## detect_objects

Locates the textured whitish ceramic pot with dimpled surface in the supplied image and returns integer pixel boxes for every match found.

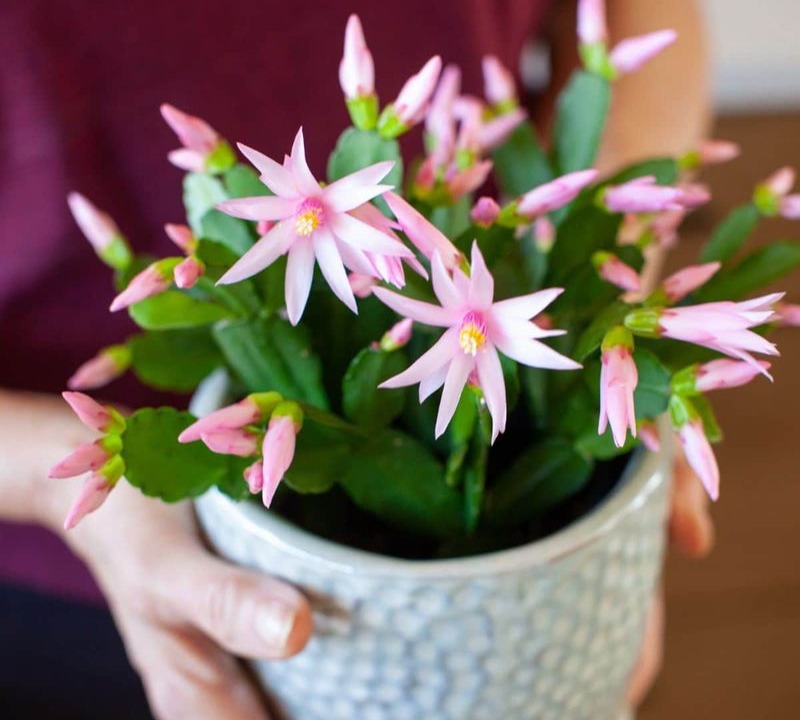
[193,372,671,720]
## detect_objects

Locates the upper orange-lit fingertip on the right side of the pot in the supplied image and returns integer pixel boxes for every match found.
[669,455,714,557]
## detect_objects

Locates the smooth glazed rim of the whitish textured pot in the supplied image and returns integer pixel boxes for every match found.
[191,376,672,581]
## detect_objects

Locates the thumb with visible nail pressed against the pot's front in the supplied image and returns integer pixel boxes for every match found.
[165,548,312,659]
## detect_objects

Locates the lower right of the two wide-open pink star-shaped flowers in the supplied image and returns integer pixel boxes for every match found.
[374,243,580,440]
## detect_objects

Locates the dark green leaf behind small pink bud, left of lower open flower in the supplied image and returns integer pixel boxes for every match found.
[342,348,408,430]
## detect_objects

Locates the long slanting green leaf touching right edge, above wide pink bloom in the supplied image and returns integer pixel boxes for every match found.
[696,240,800,302]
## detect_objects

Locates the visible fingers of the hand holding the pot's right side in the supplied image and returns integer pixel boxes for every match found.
[627,453,714,707]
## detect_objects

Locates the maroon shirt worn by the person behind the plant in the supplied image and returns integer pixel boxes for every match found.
[0,0,551,597]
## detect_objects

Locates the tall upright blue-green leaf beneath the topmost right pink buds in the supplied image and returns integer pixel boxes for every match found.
[553,70,611,175]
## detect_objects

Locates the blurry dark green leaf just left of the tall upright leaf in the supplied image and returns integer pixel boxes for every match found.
[492,122,553,197]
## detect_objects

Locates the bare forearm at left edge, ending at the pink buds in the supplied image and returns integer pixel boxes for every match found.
[0,389,92,529]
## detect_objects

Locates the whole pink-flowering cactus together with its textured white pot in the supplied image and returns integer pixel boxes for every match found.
[53,3,800,720]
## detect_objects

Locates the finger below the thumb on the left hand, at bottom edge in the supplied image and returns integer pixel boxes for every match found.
[125,621,269,720]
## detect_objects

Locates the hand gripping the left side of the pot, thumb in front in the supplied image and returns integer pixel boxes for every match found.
[26,396,312,720]
